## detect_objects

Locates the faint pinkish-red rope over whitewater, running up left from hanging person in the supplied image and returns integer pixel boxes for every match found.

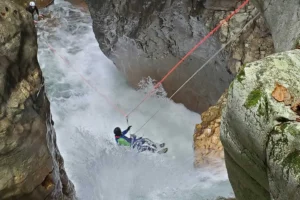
[47,44,127,118]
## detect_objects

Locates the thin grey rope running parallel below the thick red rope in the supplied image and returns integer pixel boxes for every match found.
[134,13,260,134]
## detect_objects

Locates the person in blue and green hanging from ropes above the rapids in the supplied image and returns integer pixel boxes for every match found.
[114,126,168,154]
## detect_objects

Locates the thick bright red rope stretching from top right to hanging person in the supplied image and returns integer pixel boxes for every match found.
[126,0,249,117]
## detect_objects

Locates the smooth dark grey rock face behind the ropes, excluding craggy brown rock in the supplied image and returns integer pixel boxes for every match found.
[86,0,232,112]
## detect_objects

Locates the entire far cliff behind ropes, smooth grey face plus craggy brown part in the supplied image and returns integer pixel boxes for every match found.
[86,0,273,112]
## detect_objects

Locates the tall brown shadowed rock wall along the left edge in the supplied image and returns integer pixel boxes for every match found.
[0,0,75,200]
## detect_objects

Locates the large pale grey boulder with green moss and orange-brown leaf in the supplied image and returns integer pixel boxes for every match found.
[221,50,300,200]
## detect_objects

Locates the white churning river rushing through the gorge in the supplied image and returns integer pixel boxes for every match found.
[37,0,232,200]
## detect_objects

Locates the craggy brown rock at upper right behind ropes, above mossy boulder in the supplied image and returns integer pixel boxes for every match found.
[199,0,274,74]
